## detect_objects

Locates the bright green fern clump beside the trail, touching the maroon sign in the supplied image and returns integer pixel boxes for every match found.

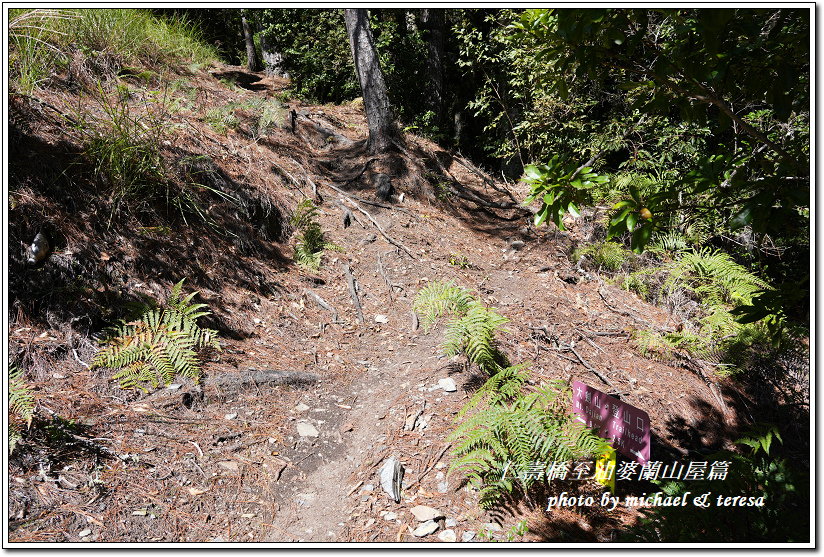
[413,282,606,507]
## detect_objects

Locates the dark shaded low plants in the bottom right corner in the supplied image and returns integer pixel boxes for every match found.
[622,426,811,543]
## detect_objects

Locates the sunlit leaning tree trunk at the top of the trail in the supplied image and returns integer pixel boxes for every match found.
[344,8,399,154]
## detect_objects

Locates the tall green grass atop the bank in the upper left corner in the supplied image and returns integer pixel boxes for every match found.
[9,8,218,93]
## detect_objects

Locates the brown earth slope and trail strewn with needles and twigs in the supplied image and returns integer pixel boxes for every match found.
[7,60,804,542]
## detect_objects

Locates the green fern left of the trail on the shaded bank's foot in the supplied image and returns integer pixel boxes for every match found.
[92,279,220,391]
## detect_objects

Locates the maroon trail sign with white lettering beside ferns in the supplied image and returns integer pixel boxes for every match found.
[572,381,649,464]
